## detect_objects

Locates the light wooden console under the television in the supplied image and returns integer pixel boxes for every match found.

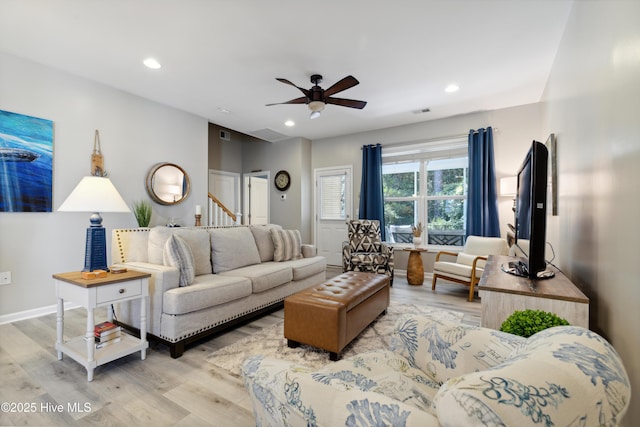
[478,255,589,330]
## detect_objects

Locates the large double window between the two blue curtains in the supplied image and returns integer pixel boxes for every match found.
[382,137,469,246]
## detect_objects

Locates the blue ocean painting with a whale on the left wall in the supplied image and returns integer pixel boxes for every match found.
[0,110,53,212]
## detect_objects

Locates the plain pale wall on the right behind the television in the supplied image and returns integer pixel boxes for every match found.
[545,0,640,426]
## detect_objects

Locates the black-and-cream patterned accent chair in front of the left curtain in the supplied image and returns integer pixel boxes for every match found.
[342,219,393,286]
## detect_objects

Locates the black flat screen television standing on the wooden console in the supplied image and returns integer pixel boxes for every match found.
[511,141,553,279]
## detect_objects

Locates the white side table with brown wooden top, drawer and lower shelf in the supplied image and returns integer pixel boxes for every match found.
[53,271,151,381]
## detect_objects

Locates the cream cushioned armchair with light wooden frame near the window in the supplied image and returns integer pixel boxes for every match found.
[431,236,509,301]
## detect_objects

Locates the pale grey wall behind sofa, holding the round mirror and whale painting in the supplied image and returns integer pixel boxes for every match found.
[0,54,208,316]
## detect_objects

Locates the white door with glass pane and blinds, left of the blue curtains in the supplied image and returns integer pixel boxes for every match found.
[315,166,352,266]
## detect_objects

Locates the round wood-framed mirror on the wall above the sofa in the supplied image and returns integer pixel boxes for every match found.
[147,163,191,205]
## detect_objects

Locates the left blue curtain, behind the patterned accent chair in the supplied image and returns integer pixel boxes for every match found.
[360,144,386,241]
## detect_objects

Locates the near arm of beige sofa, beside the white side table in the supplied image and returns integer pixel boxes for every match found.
[114,262,180,336]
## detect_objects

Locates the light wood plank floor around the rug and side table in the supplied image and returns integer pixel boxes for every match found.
[0,269,480,427]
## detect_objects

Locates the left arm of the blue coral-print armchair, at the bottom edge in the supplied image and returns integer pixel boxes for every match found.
[242,356,438,426]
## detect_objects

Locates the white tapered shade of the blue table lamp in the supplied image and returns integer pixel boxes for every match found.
[58,176,131,212]
